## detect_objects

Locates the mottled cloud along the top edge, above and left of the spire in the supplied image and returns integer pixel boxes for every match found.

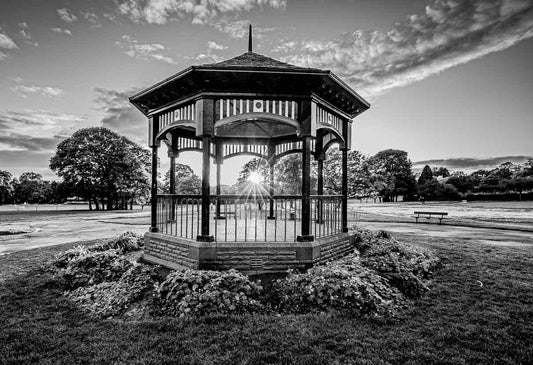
[118,0,286,24]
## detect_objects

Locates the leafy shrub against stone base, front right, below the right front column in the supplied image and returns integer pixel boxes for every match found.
[273,255,402,316]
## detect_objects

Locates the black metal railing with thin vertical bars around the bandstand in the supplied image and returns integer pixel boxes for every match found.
[157,194,353,242]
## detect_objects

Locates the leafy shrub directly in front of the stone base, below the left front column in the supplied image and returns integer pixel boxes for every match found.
[155,270,263,317]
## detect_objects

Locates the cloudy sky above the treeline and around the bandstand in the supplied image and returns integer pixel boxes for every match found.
[0,0,533,184]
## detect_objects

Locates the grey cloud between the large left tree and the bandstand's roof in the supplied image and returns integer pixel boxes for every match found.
[94,88,148,146]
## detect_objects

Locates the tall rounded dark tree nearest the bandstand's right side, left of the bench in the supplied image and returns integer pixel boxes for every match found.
[368,149,416,201]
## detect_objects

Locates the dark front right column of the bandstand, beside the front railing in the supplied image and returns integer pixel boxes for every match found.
[296,137,315,242]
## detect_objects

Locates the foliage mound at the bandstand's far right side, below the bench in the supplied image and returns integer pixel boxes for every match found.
[355,231,440,298]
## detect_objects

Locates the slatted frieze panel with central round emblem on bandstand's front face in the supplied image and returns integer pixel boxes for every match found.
[215,99,298,120]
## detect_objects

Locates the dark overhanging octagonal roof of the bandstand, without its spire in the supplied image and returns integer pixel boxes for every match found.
[130,51,370,118]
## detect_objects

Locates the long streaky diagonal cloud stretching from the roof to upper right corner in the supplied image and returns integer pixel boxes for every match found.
[283,0,533,98]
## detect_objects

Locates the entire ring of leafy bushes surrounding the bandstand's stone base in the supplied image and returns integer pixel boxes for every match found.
[50,231,440,317]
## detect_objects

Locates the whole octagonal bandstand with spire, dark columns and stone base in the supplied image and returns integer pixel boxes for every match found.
[130,31,370,273]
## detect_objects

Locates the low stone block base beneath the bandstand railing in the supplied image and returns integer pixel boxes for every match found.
[143,232,355,274]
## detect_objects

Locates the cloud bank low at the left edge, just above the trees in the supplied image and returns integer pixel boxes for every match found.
[0,110,86,152]
